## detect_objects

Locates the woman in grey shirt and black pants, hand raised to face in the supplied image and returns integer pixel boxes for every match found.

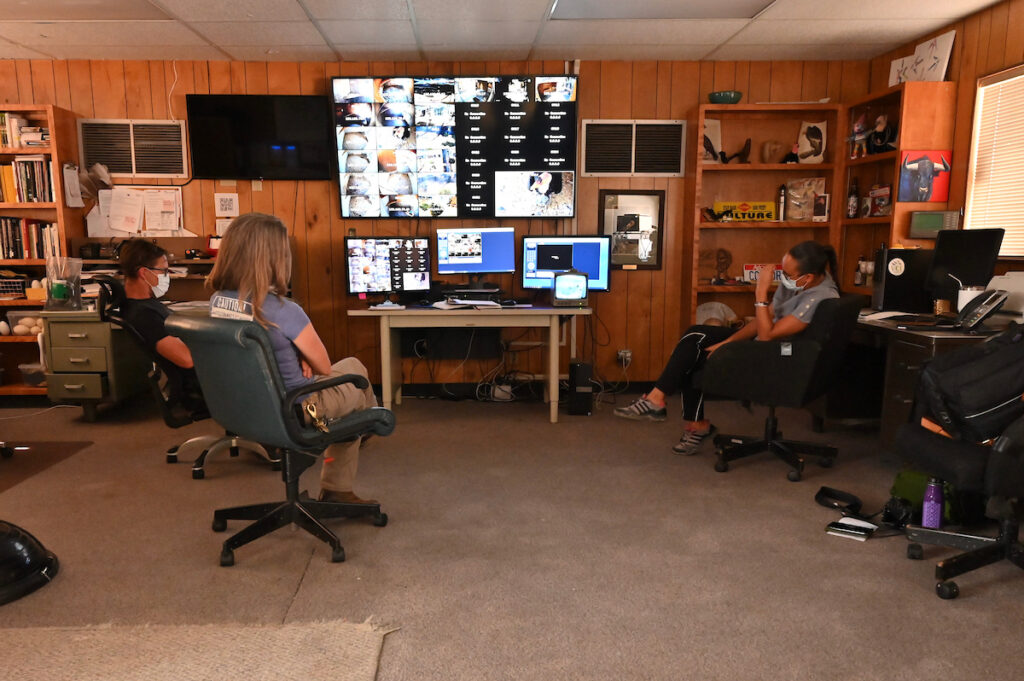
[614,241,839,456]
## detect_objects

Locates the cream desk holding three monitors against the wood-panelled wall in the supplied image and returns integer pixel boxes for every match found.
[348,307,591,423]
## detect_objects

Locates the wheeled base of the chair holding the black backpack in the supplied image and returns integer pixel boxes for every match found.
[906,518,1024,599]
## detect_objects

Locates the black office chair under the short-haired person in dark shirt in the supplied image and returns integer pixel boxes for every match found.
[92,274,281,480]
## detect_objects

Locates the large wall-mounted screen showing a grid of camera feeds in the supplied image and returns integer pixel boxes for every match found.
[331,76,577,218]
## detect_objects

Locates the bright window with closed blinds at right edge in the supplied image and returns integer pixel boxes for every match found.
[964,65,1024,257]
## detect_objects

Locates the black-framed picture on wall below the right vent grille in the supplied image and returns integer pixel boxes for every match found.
[597,189,665,269]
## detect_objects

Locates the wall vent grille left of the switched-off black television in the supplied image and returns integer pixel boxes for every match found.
[78,119,188,177]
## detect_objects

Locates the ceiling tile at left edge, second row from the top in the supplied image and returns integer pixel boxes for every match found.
[0,22,205,47]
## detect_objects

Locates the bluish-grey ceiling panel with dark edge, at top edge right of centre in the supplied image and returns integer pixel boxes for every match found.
[552,0,771,19]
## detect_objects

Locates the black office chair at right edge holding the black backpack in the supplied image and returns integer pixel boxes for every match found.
[894,417,1024,599]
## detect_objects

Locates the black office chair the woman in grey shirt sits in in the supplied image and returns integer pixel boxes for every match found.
[695,294,866,482]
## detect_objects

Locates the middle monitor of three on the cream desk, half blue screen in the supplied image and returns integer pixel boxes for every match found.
[437,227,515,274]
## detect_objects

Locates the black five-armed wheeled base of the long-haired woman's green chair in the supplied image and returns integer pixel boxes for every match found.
[213,451,387,567]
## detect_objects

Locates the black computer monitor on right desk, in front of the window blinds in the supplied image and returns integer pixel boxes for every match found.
[925,229,1002,300]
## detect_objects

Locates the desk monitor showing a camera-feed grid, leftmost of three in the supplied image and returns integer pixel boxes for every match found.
[345,237,430,295]
